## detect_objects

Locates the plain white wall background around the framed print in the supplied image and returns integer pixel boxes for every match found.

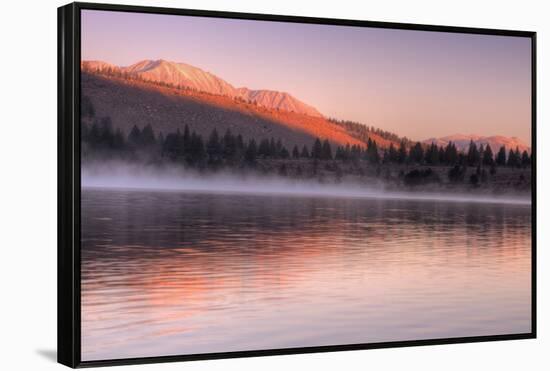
[0,0,550,371]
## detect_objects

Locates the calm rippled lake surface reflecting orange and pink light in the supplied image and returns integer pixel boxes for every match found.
[82,189,531,360]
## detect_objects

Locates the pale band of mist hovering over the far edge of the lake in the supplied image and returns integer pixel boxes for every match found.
[81,162,531,205]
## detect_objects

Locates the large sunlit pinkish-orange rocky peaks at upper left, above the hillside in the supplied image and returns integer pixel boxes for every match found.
[81,59,323,117]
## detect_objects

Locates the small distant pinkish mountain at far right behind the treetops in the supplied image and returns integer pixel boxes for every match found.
[423,134,531,153]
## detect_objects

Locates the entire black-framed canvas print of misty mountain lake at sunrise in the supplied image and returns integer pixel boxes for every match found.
[58,3,536,367]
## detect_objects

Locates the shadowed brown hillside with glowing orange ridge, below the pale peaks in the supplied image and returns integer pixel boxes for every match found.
[81,73,374,148]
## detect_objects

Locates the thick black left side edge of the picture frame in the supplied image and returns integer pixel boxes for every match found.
[57,3,80,368]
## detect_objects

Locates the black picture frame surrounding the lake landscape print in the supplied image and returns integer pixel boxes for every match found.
[57,3,537,367]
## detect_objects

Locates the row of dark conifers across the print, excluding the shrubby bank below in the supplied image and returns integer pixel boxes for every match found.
[81,115,531,167]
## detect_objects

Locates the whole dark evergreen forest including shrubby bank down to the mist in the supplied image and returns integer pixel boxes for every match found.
[81,109,531,192]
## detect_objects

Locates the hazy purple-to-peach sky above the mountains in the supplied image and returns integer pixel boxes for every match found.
[82,10,531,144]
